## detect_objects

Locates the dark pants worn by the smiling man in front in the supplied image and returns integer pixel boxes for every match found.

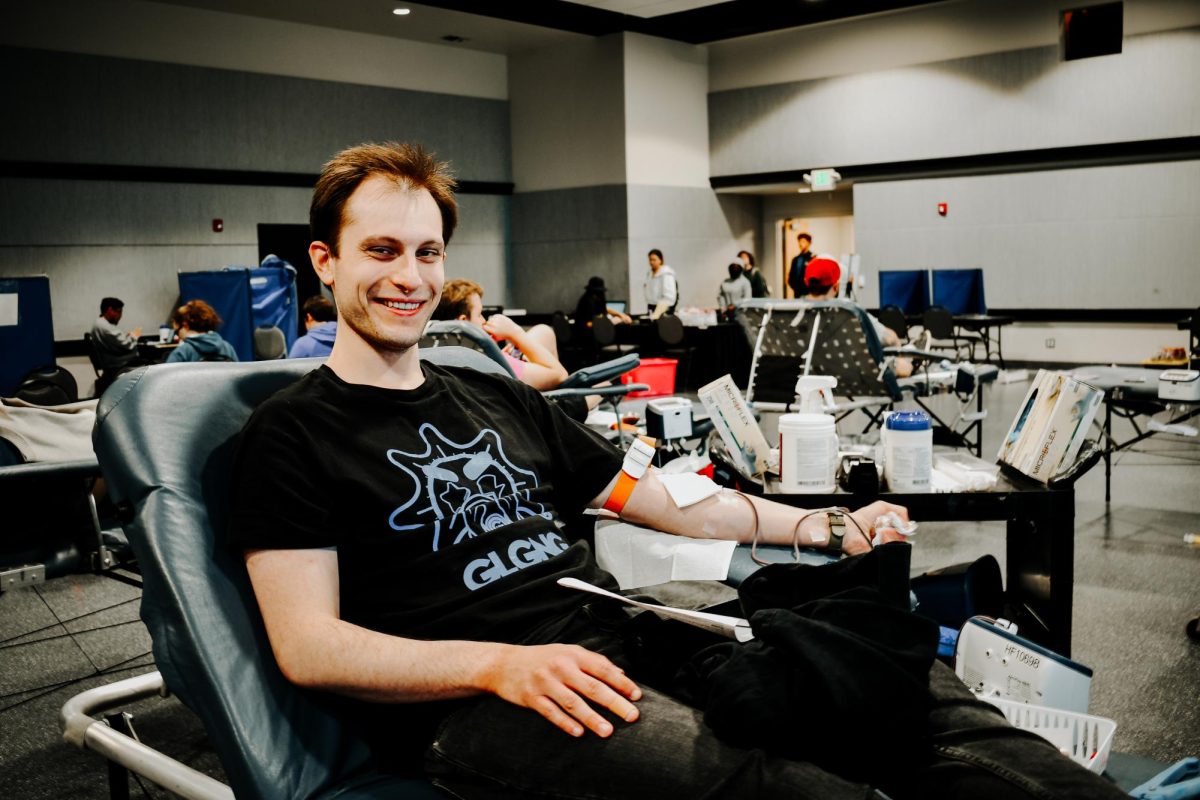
[426,618,1127,800]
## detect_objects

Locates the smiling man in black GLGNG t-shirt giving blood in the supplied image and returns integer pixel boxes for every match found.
[230,143,1124,800]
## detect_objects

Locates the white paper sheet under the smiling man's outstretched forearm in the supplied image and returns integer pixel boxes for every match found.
[596,519,737,589]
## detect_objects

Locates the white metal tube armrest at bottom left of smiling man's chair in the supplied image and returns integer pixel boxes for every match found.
[59,672,234,800]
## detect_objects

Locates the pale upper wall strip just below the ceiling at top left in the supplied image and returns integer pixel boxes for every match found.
[0,0,508,99]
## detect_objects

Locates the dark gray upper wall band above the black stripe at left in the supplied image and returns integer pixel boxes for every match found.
[0,47,511,181]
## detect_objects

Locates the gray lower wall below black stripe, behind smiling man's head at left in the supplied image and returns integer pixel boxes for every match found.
[0,179,509,339]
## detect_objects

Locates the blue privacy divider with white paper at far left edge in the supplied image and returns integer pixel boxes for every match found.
[0,275,54,397]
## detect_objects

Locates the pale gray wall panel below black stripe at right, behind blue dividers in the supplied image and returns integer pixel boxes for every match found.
[854,161,1200,308]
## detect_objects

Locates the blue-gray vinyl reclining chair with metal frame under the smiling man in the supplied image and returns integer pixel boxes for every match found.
[60,357,511,800]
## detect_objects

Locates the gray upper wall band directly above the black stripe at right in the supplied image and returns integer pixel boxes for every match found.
[708,29,1200,175]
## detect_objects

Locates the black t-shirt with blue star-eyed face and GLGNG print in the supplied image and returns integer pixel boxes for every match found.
[225,362,623,643]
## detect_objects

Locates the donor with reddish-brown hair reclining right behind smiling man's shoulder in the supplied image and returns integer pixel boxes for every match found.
[433,278,566,391]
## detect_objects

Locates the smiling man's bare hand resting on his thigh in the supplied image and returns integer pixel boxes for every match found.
[484,644,642,736]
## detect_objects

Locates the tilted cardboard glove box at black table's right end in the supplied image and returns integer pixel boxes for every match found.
[996,369,1104,483]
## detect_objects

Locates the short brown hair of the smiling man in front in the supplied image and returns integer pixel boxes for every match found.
[308,142,458,255]
